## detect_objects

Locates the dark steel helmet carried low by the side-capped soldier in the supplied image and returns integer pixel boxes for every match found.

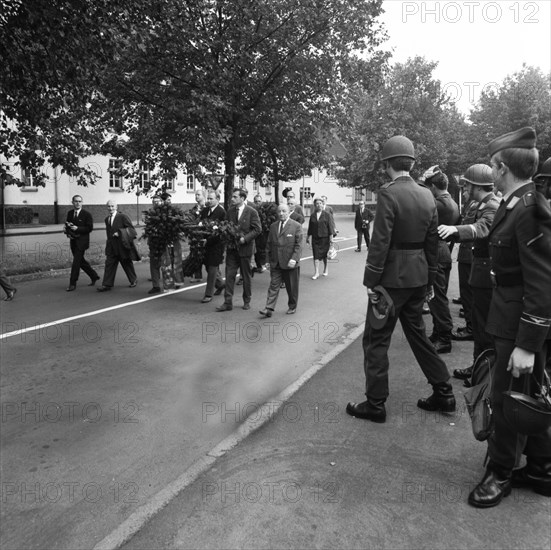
[503,376,551,435]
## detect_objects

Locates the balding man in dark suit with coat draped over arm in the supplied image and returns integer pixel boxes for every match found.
[98,200,140,292]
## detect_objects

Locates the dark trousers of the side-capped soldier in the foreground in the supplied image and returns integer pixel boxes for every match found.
[488,336,551,471]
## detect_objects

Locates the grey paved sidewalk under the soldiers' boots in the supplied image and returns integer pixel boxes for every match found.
[123,333,551,550]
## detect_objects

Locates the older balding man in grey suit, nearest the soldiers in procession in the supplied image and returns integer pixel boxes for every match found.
[260,204,302,317]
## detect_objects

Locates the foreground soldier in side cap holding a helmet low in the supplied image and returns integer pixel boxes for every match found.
[469,128,551,508]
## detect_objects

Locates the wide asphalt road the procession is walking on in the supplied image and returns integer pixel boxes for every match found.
[0,217,380,549]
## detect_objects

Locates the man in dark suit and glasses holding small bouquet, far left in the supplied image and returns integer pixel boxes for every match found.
[65,195,99,292]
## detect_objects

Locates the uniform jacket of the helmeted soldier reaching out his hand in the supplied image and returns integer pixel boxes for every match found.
[457,193,499,288]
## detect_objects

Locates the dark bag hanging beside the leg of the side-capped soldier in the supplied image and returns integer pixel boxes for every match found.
[464,349,495,441]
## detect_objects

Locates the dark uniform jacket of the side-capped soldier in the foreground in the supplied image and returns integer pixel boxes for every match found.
[486,182,551,352]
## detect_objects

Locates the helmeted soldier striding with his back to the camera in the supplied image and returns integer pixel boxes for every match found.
[346,136,455,422]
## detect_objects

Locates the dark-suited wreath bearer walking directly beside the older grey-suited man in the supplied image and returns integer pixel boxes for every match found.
[216,188,262,311]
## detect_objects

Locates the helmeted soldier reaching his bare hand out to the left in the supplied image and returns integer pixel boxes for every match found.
[438,164,499,380]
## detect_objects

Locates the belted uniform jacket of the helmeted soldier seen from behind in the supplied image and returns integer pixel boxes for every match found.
[363,176,438,288]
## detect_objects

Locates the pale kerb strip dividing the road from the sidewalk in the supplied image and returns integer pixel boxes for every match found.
[93,326,364,550]
